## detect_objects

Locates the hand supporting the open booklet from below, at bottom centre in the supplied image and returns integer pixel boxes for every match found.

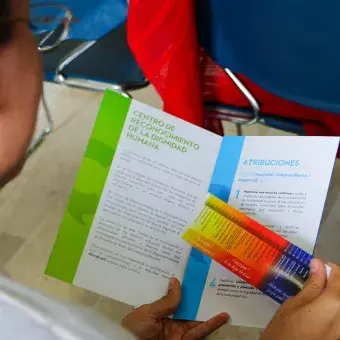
[122,278,229,340]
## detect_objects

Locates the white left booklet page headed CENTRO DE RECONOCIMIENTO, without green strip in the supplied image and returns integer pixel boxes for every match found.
[74,101,222,305]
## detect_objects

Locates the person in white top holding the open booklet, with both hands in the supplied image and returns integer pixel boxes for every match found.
[0,0,340,340]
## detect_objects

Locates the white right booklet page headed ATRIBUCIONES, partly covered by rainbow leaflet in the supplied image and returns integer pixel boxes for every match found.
[197,137,339,327]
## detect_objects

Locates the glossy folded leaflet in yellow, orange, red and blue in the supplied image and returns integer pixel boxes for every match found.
[183,194,313,303]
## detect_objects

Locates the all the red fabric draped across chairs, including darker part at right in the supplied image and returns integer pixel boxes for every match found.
[128,0,340,140]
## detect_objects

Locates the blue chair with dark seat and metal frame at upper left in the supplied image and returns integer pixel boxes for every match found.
[30,0,148,153]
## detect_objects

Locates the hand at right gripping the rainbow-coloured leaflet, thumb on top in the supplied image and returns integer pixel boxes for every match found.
[261,259,340,340]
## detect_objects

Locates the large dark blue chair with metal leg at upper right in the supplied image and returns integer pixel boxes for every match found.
[197,0,340,135]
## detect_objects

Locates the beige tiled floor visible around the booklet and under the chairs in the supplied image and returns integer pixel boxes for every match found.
[0,84,340,340]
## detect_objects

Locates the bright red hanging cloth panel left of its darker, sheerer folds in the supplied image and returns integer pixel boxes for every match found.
[128,0,204,126]
